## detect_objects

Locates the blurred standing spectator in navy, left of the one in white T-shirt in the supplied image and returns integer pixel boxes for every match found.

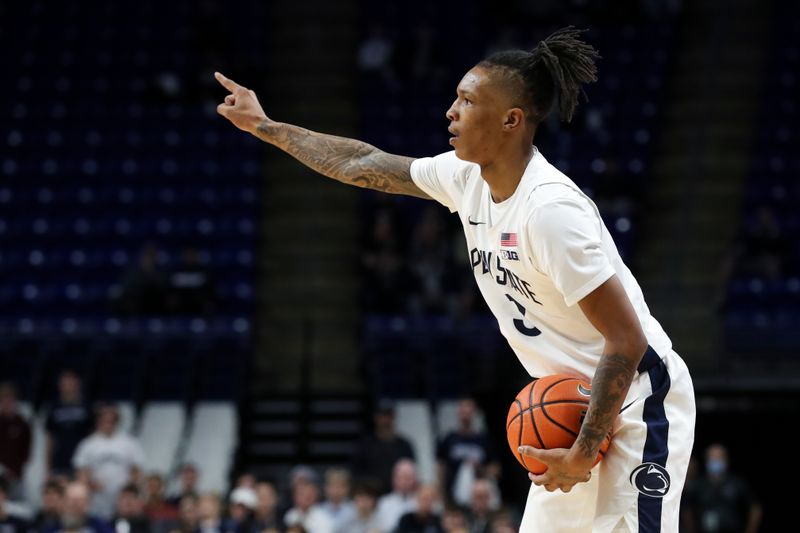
[46,370,92,476]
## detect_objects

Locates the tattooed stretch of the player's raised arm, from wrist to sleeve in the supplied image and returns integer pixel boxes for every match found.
[256,121,430,199]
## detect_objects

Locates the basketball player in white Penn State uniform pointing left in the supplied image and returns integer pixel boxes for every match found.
[216,28,695,533]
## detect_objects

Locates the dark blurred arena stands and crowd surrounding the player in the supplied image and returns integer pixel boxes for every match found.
[0,0,800,533]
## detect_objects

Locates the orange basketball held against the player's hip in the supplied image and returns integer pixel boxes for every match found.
[506,374,611,474]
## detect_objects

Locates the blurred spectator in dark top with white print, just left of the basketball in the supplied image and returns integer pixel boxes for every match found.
[436,398,500,505]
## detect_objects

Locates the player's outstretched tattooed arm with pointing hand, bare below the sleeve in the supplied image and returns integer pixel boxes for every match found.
[214,72,430,199]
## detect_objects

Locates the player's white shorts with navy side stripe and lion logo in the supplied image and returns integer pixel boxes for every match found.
[520,348,695,533]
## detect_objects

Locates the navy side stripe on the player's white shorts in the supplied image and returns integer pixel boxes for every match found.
[639,346,671,533]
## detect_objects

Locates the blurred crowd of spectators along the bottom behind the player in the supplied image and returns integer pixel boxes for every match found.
[0,371,762,533]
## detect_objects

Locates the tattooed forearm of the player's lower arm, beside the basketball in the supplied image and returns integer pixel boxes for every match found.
[578,354,636,458]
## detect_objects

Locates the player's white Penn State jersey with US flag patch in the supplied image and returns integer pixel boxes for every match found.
[411,148,672,380]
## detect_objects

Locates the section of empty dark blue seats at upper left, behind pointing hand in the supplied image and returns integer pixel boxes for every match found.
[0,0,261,350]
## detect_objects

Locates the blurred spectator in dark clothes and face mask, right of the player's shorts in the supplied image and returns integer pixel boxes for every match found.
[684,444,762,533]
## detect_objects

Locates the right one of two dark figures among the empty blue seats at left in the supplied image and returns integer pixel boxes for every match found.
[167,248,216,315]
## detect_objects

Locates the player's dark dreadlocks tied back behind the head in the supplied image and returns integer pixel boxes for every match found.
[478,26,600,123]
